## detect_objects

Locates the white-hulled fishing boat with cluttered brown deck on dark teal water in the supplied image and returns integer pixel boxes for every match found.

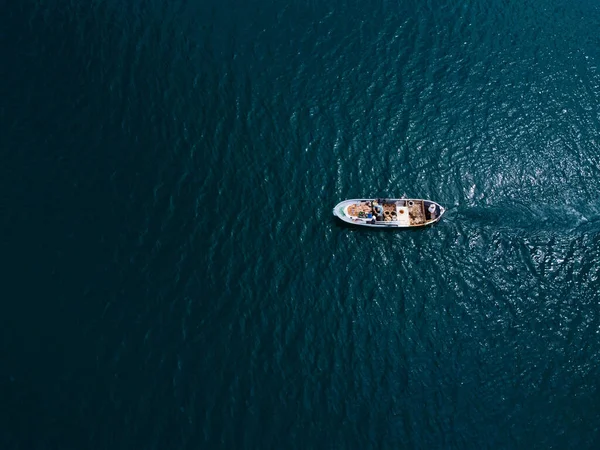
[333,198,446,228]
